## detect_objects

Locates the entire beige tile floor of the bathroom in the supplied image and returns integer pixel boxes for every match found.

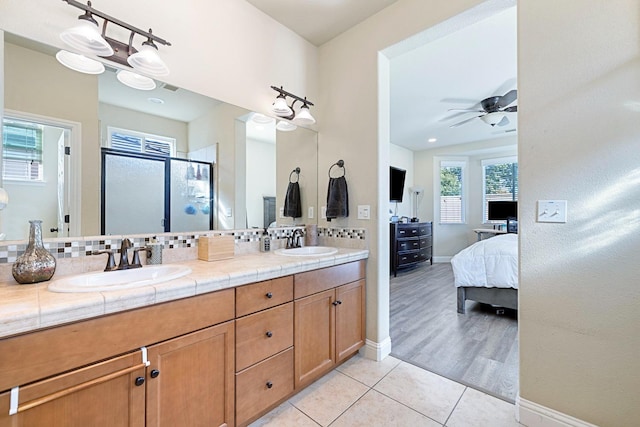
[250,355,520,427]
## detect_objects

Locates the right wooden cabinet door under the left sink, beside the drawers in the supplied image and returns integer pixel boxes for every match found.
[147,321,235,427]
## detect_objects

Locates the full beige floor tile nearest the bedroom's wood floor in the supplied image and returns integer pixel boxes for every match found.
[374,362,465,424]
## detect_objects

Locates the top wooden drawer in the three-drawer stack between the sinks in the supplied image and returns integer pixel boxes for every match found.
[236,276,293,317]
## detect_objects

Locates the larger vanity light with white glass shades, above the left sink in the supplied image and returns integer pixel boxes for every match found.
[56,0,171,84]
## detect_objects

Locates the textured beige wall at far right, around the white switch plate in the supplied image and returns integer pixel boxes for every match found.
[518,0,640,427]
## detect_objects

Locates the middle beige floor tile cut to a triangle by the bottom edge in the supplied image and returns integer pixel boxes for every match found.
[331,390,440,427]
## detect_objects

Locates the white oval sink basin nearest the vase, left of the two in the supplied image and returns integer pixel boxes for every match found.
[49,264,191,292]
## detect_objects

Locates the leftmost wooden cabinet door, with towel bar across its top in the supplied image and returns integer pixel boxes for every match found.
[0,352,145,427]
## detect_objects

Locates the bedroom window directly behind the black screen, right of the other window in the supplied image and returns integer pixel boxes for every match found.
[482,157,518,223]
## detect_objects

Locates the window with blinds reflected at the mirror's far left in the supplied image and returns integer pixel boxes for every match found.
[2,119,44,182]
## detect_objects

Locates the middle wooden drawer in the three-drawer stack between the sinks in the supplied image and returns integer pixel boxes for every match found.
[236,302,293,371]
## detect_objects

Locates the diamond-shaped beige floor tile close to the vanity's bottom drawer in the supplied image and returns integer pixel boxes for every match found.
[289,371,369,426]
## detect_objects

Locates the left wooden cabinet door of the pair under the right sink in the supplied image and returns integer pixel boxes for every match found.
[293,289,335,389]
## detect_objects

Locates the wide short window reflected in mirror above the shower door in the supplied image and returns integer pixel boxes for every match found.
[107,126,176,157]
